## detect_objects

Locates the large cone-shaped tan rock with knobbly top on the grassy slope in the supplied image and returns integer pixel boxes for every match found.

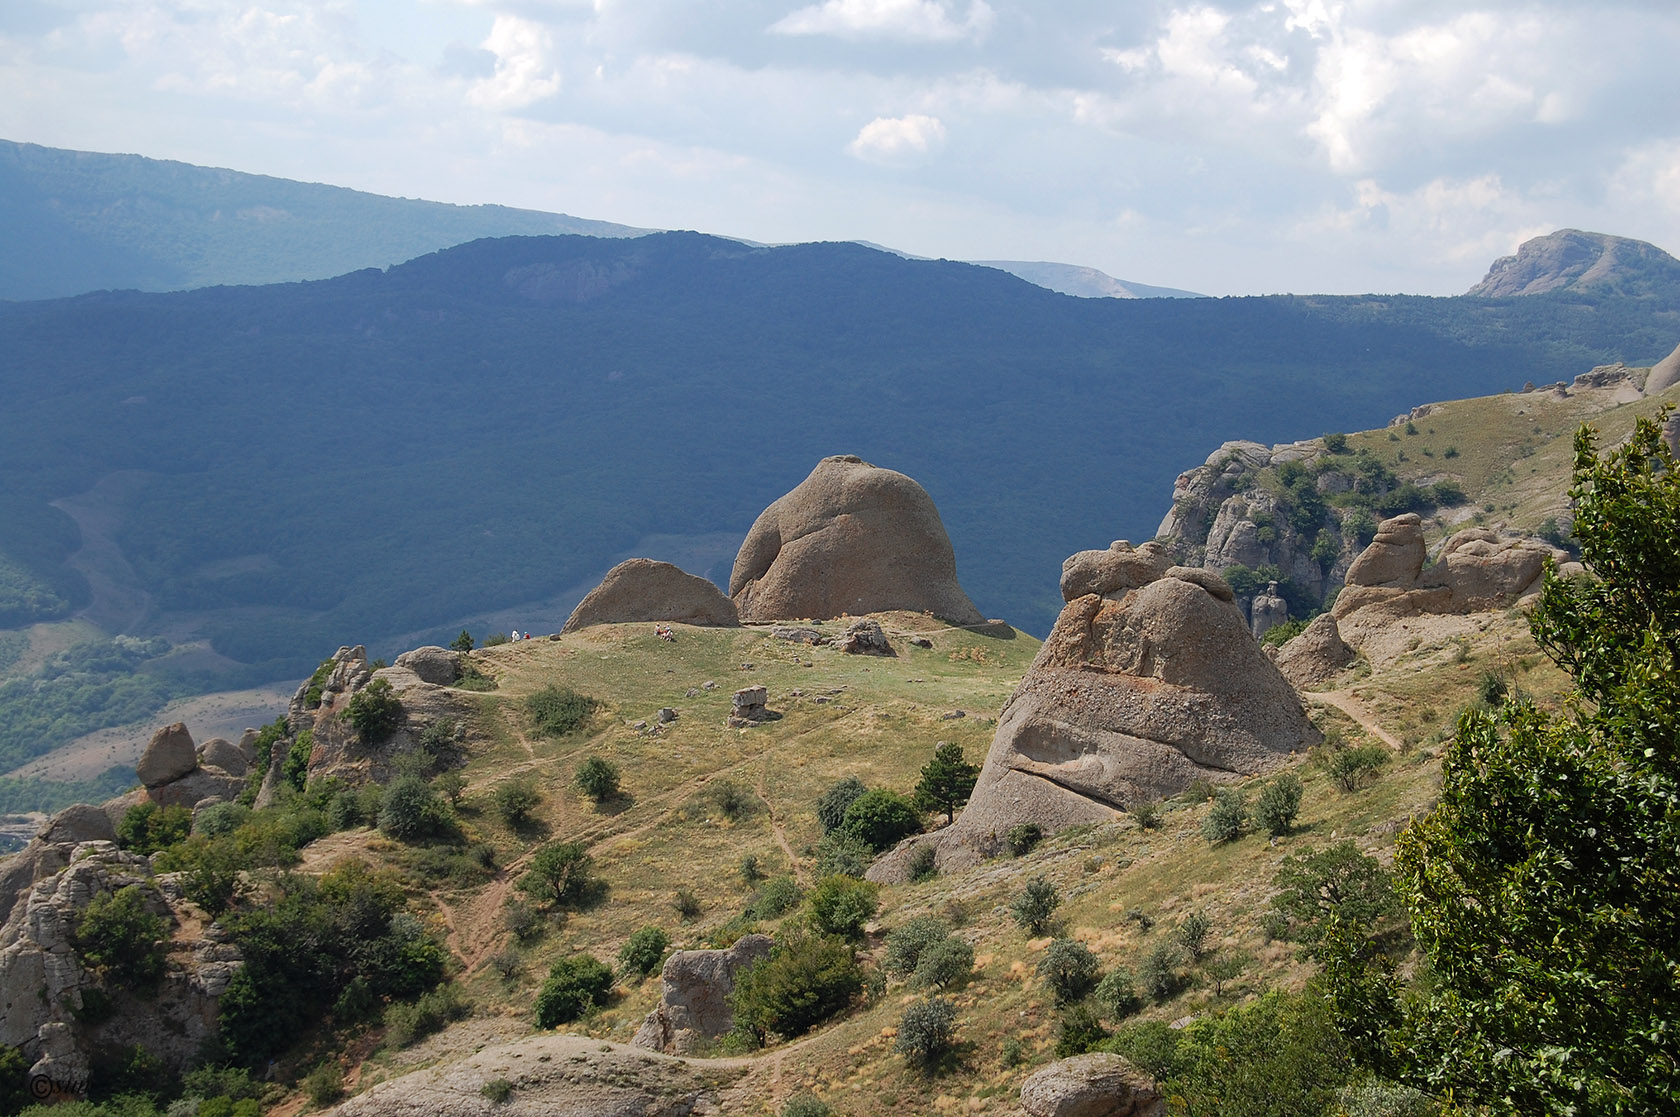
[870,566,1319,880]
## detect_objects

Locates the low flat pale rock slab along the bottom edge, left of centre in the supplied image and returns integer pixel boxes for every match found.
[328,1035,744,1117]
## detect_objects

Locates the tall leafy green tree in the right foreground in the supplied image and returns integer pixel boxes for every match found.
[1352,411,1680,1114]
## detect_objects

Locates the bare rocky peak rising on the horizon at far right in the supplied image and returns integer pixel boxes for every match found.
[1465,228,1680,302]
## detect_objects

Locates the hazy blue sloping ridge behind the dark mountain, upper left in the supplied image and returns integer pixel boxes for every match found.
[0,139,647,299]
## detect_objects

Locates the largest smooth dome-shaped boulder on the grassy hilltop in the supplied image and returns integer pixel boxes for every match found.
[729,455,984,625]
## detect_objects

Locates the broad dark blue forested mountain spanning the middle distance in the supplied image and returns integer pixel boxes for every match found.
[0,233,1680,677]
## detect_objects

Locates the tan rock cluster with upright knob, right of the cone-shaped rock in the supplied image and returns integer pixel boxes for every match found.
[1331,512,1569,647]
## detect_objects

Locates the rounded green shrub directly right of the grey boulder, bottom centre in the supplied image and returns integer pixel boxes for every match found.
[729,927,864,1043]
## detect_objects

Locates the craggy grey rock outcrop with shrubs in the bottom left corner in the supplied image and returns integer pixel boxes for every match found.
[0,842,240,1085]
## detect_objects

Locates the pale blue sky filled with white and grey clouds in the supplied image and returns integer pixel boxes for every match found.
[0,0,1680,294]
